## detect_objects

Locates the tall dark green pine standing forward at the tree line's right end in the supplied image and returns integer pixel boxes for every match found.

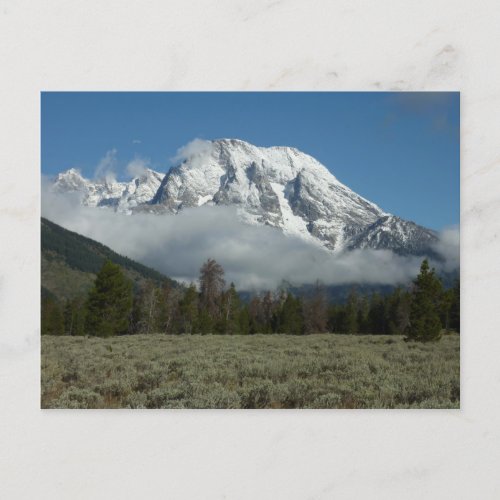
[407,259,442,342]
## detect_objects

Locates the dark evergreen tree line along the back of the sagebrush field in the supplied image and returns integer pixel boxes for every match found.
[41,259,460,341]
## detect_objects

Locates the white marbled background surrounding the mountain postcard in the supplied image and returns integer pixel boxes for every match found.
[0,0,500,499]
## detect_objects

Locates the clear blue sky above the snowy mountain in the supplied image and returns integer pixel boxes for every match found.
[41,92,460,229]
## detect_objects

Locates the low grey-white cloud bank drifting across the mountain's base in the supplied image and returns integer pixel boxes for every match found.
[42,186,459,290]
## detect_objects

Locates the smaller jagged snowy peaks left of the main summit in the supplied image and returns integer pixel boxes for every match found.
[53,168,164,212]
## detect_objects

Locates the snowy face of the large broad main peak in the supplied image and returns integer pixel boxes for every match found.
[152,139,394,250]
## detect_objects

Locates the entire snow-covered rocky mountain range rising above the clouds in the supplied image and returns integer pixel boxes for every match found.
[54,139,437,255]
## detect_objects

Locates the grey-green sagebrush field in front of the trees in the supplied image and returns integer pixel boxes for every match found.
[41,334,460,408]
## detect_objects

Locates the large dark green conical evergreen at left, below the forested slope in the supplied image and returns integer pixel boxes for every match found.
[85,260,132,337]
